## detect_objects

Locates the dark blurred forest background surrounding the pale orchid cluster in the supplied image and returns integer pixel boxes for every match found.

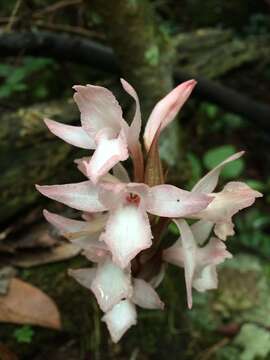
[0,0,270,360]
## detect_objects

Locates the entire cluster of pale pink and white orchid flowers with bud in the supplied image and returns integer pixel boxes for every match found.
[37,80,261,342]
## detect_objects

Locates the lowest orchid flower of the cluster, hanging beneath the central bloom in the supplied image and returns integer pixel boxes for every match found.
[69,257,164,342]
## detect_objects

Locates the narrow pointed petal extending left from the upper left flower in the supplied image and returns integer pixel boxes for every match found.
[44,119,96,149]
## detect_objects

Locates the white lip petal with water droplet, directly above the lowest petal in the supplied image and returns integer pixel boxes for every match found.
[91,259,132,312]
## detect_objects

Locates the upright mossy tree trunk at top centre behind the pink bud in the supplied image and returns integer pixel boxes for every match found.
[89,0,175,119]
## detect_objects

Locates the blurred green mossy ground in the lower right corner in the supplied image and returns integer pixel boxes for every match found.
[188,255,270,360]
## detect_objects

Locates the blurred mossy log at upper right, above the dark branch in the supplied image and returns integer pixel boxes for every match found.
[174,29,270,79]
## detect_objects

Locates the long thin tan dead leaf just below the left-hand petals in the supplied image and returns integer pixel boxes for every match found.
[11,243,81,268]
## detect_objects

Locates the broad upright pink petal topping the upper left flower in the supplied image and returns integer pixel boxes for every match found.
[73,85,124,137]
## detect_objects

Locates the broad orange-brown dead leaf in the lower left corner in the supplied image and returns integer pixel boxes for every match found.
[0,278,61,329]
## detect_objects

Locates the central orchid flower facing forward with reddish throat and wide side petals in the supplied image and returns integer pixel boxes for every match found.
[37,180,212,268]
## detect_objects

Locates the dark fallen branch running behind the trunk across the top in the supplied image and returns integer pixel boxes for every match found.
[0,32,270,129]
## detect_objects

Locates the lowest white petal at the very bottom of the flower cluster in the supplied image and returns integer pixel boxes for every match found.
[102,300,137,343]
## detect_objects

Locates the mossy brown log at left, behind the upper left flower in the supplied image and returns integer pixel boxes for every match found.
[0,101,84,224]
